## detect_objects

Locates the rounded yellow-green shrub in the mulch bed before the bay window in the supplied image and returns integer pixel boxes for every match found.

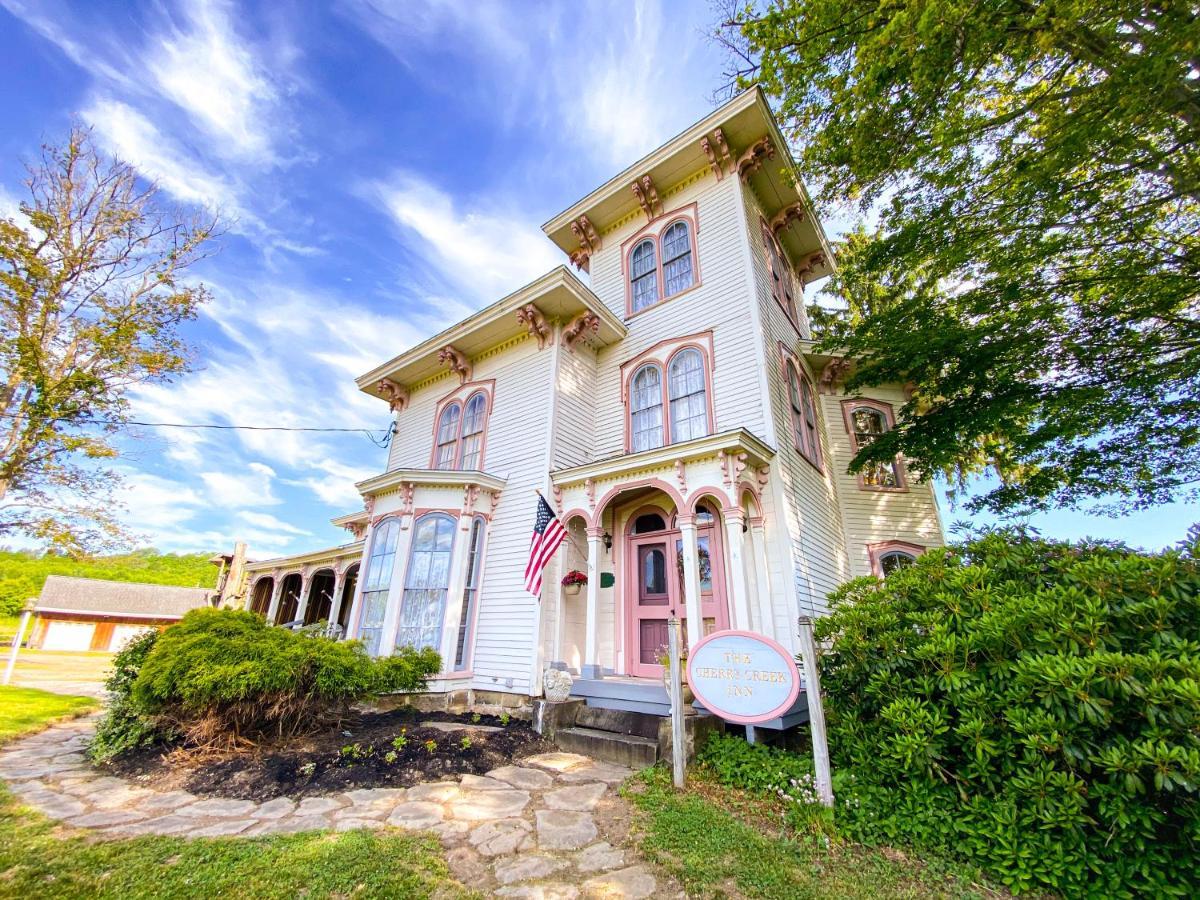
[132,610,440,748]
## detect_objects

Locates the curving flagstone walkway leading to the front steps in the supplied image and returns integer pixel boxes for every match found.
[0,719,682,900]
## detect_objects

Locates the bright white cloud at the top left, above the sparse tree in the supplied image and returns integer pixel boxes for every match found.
[146,0,280,162]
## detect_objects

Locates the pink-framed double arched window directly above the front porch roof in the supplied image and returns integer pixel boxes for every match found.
[620,331,713,454]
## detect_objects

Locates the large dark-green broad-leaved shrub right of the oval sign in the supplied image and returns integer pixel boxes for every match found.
[817,530,1200,896]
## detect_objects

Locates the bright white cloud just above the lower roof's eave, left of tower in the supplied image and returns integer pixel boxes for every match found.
[361,172,564,302]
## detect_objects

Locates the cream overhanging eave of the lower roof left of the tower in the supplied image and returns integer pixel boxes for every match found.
[355,265,625,398]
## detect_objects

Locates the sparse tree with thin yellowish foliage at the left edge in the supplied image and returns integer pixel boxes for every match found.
[0,127,215,554]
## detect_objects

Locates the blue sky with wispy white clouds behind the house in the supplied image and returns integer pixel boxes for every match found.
[0,0,1200,558]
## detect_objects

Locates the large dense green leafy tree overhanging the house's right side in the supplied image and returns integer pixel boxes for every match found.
[719,0,1200,511]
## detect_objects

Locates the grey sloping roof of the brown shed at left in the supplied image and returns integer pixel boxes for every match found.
[34,575,212,619]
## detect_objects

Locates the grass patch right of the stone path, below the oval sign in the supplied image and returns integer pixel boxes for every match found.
[624,768,1003,900]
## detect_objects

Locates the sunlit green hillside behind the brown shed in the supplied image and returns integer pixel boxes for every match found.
[0,550,218,614]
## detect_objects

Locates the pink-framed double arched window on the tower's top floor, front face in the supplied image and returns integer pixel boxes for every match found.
[624,203,700,316]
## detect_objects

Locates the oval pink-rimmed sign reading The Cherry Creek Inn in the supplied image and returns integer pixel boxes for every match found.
[688,631,800,725]
